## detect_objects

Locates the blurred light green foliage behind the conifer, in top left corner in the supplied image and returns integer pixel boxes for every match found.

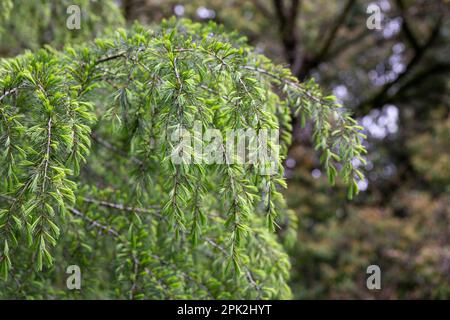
[0,0,124,56]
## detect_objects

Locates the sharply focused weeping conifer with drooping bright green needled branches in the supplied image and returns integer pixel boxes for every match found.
[0,20,365,299]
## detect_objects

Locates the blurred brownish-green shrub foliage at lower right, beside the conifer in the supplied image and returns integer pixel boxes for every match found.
[286,146,450,299]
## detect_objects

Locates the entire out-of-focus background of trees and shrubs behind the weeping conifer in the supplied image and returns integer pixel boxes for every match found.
[0,0,450,299]
